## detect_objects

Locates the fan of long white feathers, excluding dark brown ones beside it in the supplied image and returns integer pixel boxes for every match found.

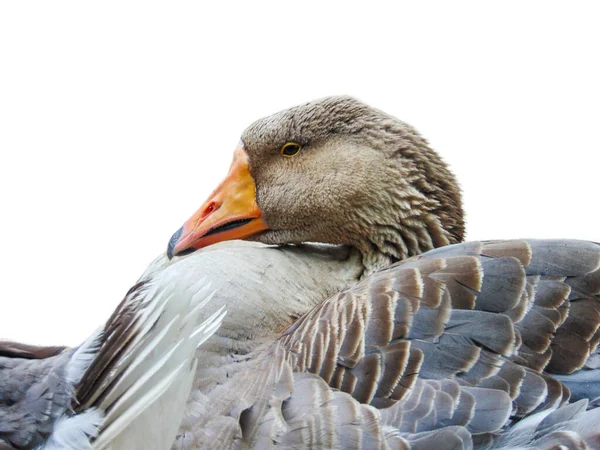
[93,271,225,450]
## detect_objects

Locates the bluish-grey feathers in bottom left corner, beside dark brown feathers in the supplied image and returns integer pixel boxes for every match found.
[0,333,101,449]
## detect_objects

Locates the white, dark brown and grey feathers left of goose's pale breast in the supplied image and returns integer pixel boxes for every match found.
[0,270,224,450]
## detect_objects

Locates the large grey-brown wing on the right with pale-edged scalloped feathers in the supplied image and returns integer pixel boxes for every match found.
[190,241,600,449]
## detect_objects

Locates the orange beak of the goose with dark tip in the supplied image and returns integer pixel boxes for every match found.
[167,144,267,259]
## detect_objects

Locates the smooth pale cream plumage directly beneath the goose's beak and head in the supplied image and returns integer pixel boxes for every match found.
[140,241,362,374]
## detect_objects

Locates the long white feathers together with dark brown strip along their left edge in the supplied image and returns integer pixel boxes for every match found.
[75,271,225,449]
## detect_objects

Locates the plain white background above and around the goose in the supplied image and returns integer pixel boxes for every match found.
[0,1,600,345]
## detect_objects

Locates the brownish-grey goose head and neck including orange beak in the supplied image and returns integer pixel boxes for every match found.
[167,97,464,273]
